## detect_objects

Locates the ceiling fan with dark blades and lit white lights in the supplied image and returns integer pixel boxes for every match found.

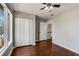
[40,3,60,12]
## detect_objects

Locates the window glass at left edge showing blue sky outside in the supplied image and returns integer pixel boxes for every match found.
[0,5,4,48]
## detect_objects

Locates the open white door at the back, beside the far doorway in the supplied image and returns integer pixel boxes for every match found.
[40,22,47,40]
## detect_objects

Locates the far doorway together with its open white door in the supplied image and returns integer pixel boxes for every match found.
[39,22,52,41]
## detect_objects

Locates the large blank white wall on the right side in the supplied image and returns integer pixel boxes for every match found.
[50,8,79,53]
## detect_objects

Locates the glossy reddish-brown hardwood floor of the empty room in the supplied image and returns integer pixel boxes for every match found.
[11,39,79,56]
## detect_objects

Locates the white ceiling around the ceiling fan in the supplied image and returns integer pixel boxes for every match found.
[9,3,79,19]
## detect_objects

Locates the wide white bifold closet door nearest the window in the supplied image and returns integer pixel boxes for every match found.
[15,18,30,47]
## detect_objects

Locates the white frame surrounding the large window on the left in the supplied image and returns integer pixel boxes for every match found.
[0,3,13,55]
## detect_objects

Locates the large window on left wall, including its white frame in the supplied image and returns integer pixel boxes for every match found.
[0,4,12,52]
